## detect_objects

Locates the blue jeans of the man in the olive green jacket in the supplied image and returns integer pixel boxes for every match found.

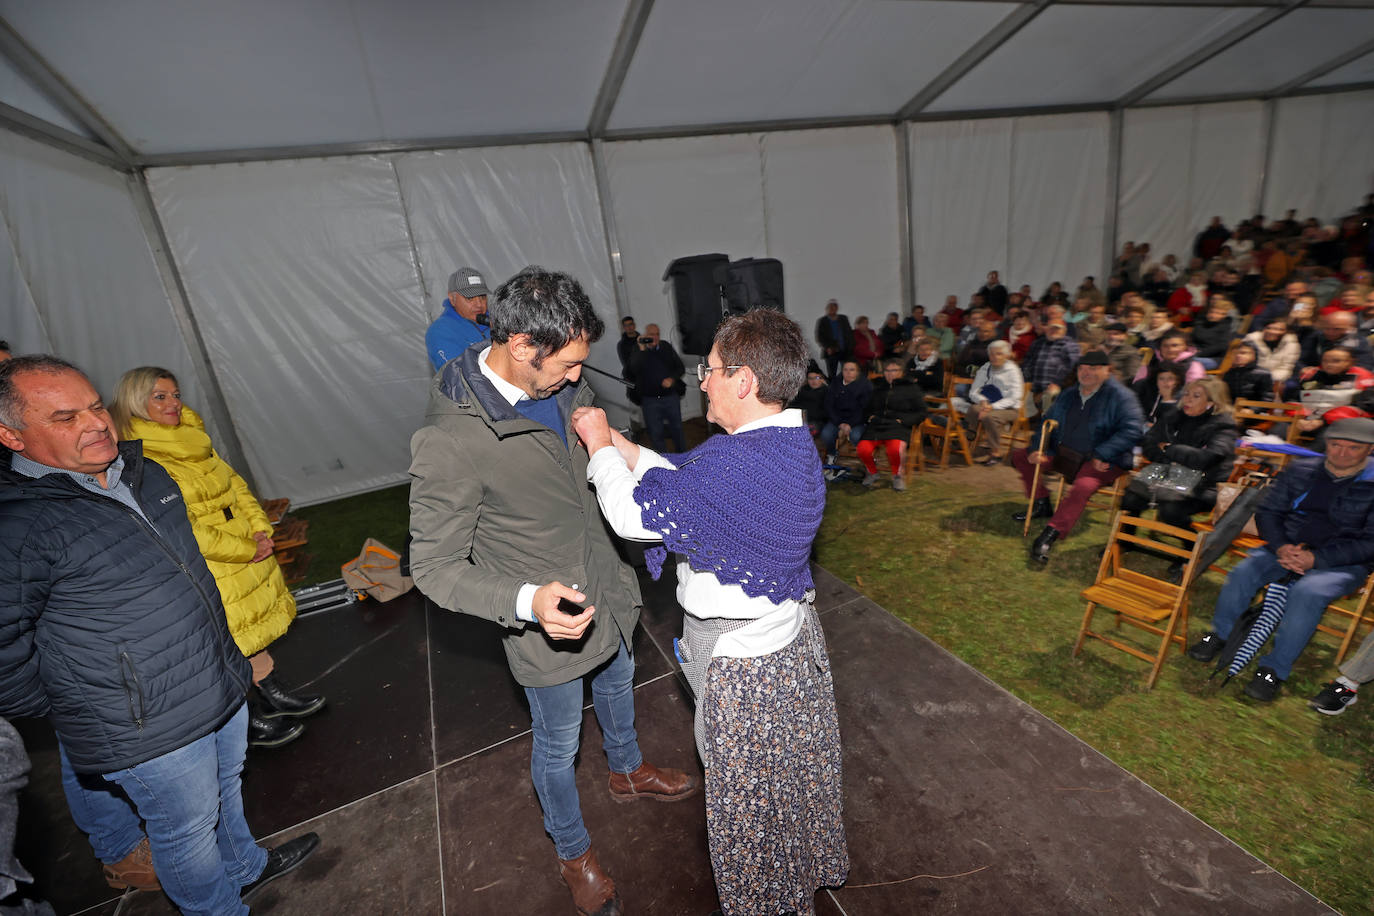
[525,640,644,860]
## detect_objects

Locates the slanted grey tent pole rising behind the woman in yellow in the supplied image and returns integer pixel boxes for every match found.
[129,177,257,492]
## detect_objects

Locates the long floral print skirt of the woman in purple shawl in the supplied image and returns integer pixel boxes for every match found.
[701,608,849,916]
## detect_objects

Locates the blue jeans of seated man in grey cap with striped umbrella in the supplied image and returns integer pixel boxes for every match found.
[1212,547,1369,681]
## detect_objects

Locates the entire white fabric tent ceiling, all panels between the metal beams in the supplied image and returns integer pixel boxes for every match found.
[0,0,1374,162]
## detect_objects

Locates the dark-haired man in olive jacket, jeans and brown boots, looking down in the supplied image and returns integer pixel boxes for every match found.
[411,266,701,916]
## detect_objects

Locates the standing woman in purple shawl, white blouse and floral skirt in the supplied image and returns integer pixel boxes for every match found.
[573,309,849,916]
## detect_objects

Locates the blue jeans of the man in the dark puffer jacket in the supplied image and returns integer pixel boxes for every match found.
[104,703,267,916]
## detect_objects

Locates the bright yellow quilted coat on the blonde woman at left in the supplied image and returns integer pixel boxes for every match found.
[129,407,295,655]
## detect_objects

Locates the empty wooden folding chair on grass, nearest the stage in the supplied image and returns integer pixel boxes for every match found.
[1073,512,1202,688]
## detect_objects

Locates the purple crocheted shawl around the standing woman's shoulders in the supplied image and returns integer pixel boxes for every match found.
[635,426,826,603]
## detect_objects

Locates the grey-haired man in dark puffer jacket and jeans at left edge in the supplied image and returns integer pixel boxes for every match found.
[0,356,319,913]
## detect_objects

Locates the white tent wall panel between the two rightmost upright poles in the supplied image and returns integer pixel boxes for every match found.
[1117,102,1264,265]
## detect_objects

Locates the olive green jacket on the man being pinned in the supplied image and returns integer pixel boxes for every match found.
[411,341,640,687]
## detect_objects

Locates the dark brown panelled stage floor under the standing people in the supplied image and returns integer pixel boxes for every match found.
[19,570,1330,916]
